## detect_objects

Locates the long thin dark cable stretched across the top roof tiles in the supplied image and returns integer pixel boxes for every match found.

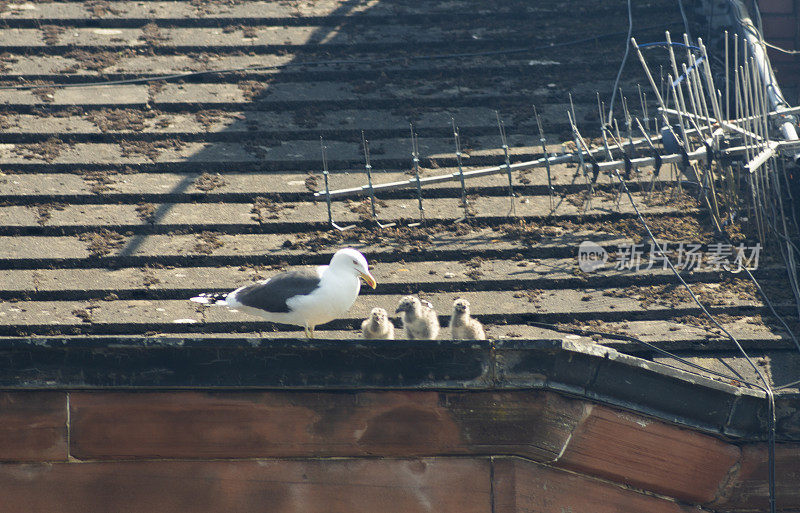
[0,22,688,90]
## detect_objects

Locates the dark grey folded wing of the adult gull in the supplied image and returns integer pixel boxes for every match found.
[236,271,319,313]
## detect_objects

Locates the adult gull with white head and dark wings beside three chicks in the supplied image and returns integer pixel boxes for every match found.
[191,248,377,338]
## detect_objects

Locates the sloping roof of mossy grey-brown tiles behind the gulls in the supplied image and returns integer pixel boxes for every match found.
[0,1,796,390]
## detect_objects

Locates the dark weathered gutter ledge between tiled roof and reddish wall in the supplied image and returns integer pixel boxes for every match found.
[0,337,800,441]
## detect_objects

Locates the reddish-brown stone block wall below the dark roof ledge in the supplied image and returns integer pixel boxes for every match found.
[0,391,800,513]
